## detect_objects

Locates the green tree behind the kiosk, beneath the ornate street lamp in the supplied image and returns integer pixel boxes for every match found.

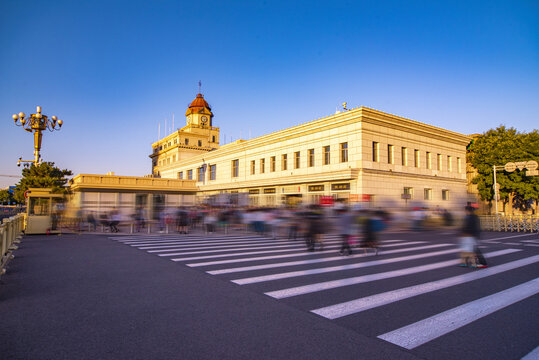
[15,162,73,203]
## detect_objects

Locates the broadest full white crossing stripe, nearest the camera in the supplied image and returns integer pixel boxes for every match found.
[378,278,539,349]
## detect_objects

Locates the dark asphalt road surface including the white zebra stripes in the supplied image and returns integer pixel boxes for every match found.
[0,231,539,359]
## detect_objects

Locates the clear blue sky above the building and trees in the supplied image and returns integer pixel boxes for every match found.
[0,0,539,187]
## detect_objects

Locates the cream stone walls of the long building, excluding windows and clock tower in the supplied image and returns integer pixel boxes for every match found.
[154,107,469,208]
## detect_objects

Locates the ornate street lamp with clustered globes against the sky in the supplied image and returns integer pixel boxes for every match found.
[12,106,64,166]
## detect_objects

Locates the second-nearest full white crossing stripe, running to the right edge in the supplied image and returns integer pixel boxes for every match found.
[312,255,539,319]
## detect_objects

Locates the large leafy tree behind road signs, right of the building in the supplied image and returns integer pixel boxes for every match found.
[468,126,539,212]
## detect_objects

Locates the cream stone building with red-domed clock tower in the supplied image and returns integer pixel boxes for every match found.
[150,94,470,209]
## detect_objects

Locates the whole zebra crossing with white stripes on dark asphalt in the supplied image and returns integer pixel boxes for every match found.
[110,234,539,352]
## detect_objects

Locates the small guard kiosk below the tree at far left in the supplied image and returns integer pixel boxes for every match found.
[25,188,64,234]
